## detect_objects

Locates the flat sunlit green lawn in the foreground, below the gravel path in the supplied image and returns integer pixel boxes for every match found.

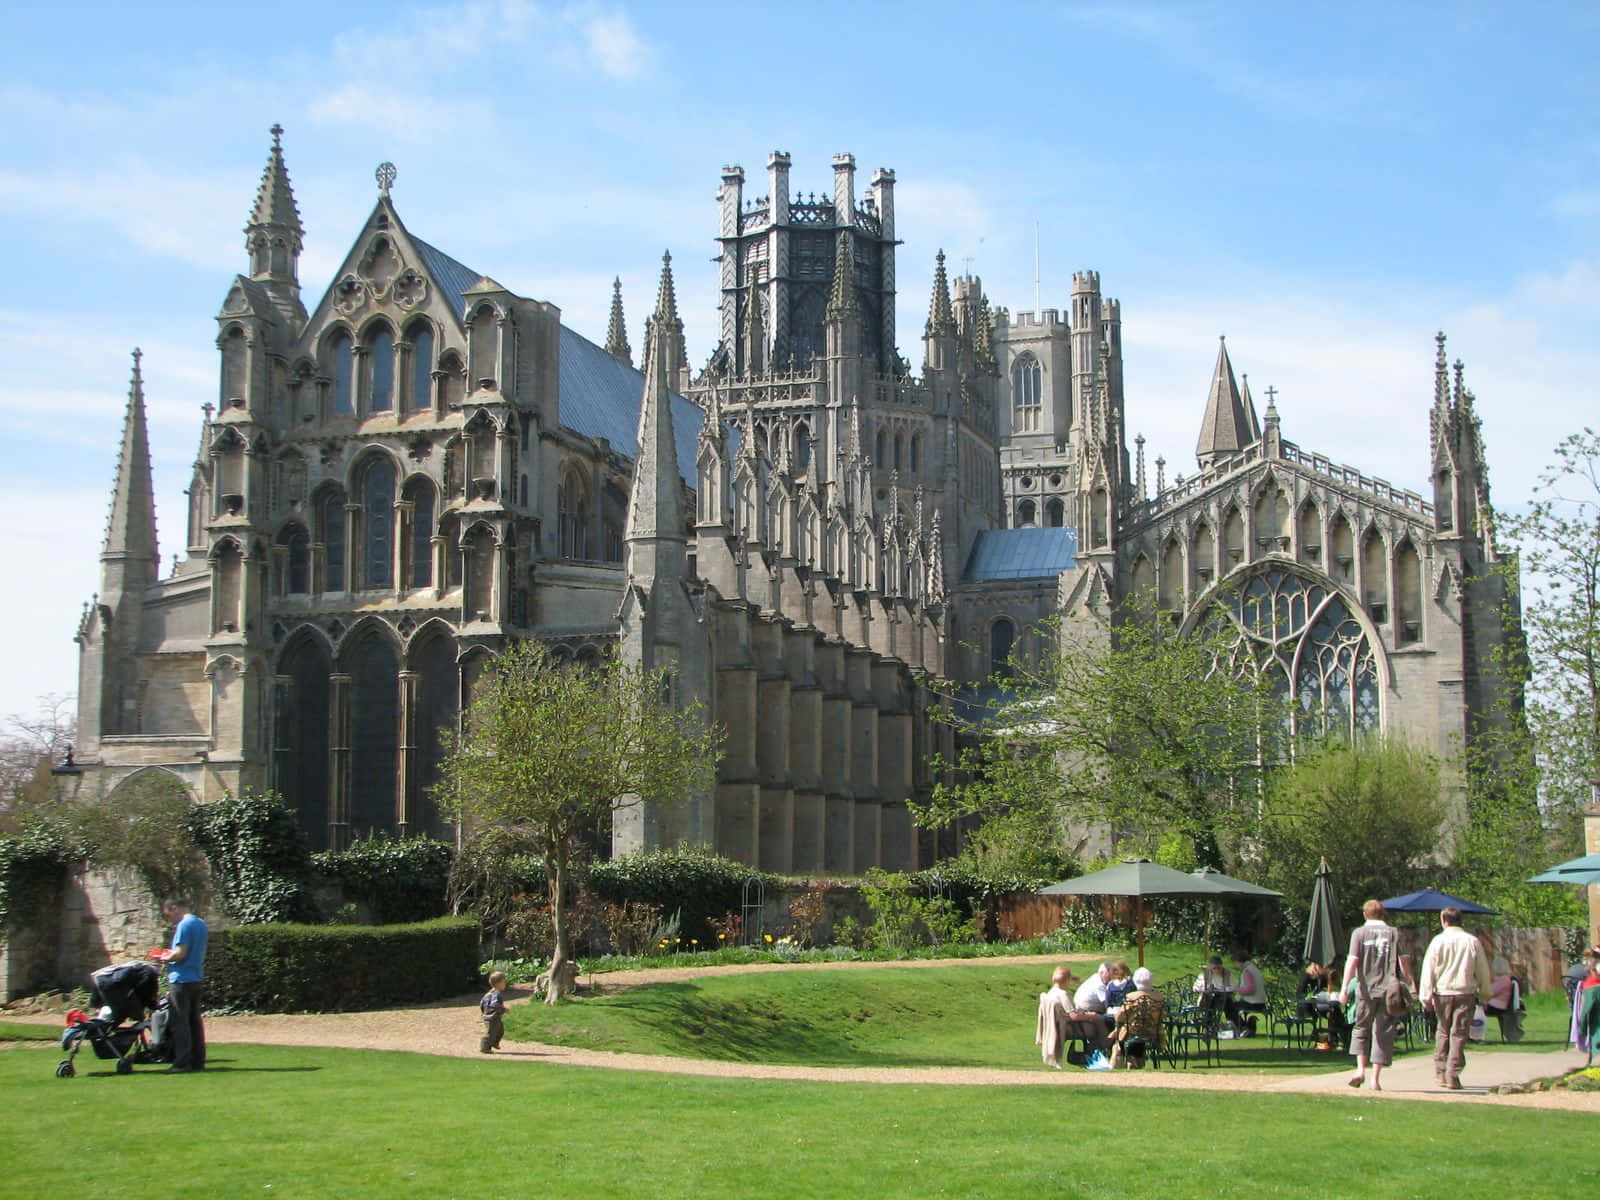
[0,1046,1600,1200]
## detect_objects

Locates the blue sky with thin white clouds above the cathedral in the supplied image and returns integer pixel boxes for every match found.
[0,0,1600,714]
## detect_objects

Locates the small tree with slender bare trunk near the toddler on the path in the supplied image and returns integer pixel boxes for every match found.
[438,642,718,1003]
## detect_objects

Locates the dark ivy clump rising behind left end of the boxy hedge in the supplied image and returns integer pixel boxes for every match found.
[187,792,312,925]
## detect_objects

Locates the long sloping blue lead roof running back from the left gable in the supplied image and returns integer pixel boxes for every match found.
[411,237,701,488]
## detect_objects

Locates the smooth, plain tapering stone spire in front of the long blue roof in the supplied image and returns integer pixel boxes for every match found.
[622,281,688,590]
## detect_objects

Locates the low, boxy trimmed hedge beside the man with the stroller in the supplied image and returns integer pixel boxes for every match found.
[206,917,482,1013]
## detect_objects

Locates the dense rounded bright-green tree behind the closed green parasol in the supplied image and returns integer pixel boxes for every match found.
[1258,738,1445,912]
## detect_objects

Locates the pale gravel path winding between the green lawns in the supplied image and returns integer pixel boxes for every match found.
[11,955,1600,1114]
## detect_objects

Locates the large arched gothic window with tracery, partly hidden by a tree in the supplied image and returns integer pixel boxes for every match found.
[1210,566,1379,738]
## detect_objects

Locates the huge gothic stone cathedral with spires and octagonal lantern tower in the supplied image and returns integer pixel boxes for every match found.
[77,128,1501,874]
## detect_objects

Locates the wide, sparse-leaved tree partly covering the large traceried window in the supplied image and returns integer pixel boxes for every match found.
[917,603,1286,867]
